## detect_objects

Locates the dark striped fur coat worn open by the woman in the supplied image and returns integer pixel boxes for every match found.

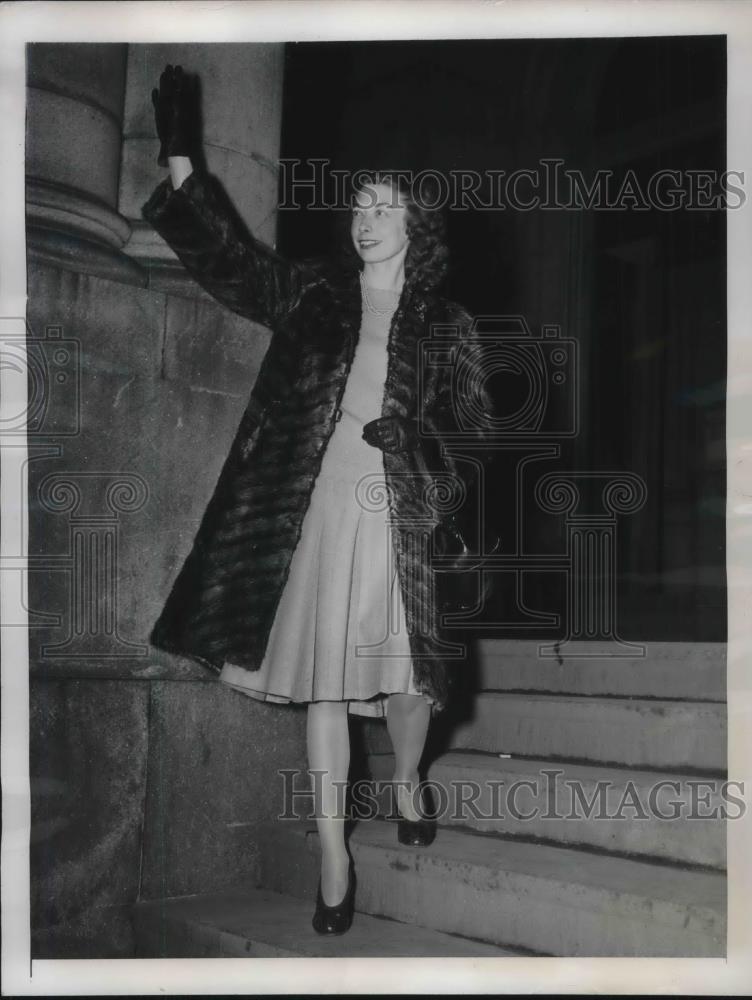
[143,172,490,709]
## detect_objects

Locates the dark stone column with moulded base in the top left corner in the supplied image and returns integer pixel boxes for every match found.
[26,43,145,284]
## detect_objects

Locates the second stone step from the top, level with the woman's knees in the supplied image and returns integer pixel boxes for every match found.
[362,691,726,773]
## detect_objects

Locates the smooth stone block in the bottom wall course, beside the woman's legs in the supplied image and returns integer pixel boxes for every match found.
[141,682,305,899]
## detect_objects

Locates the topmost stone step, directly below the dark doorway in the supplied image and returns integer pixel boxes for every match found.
[475,639,726,702]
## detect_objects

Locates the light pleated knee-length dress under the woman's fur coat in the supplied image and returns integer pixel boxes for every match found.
[220,288,431,717]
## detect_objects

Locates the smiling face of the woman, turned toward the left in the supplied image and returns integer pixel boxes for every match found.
[350,184,408,264]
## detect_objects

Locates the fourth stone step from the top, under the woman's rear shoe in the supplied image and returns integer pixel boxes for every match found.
[261,820,726,957]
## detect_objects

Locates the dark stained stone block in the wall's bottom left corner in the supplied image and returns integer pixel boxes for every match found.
[30,680,148,958]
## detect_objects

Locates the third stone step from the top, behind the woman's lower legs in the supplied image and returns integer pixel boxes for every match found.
[362,751,724,869]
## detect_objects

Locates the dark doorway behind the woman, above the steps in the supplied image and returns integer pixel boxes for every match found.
[279,36,724,641]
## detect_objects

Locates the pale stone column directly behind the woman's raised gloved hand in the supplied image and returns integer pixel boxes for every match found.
[119,44,284,278]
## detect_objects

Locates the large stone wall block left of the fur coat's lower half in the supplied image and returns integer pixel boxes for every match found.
[29,374,250,676]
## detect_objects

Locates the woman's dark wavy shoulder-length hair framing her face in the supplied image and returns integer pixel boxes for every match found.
[341,170,449,291]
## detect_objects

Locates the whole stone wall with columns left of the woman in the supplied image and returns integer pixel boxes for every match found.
[27,45,305,958]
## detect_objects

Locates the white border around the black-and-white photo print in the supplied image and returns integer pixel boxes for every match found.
[0,0,752,996]
